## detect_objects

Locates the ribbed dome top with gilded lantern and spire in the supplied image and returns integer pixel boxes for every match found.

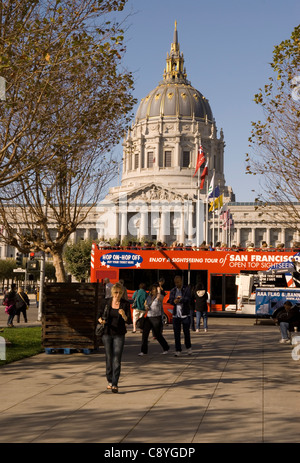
[136,22,213,123]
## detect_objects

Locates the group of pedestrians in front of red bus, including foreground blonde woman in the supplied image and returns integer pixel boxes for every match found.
[97,276,208,392]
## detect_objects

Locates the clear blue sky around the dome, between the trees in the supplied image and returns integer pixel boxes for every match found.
[106,0,300,201]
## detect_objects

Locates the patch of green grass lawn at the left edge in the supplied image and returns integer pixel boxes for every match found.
[0,326,43,367]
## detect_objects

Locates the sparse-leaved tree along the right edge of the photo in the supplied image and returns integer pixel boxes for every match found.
[246,26,300,229]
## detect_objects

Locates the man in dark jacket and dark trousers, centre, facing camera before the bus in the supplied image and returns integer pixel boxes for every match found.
[168,276,192,357]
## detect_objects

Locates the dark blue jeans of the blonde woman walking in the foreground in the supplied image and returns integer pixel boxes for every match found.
[102,334,125,386]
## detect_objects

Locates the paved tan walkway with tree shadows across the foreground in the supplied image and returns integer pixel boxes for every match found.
[0,317,300,445]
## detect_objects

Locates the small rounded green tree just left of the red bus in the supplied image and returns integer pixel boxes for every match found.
[64,240,92,281]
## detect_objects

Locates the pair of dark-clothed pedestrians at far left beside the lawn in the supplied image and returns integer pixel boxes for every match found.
[2,284,29,328]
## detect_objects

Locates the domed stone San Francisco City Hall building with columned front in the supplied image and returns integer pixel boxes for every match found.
[0,23,299,258]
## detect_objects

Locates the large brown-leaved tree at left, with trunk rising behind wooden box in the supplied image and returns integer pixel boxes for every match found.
[0,0,135,281]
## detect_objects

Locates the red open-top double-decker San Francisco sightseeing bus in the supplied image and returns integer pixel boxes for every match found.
[91,244,300,321]
